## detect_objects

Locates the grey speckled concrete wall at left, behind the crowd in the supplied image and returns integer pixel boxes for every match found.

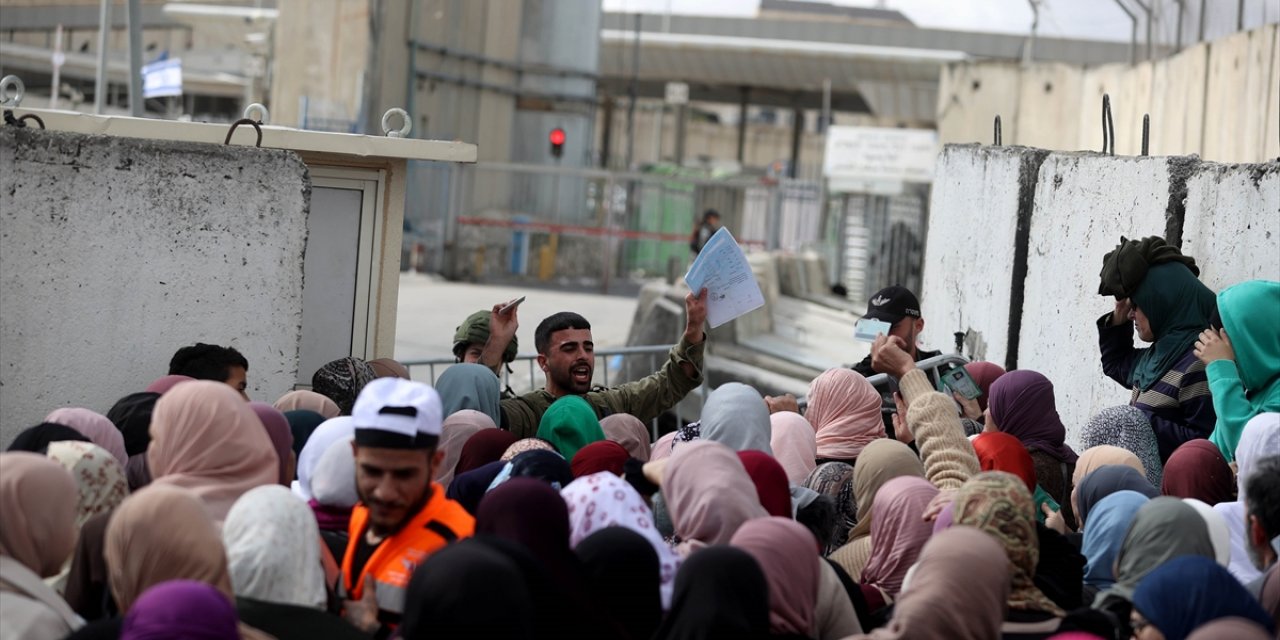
[0,127,311,443]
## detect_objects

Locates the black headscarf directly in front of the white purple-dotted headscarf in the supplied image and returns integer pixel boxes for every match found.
[573,526,662,640]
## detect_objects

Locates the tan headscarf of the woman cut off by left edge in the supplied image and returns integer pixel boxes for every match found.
[0,452,77,577]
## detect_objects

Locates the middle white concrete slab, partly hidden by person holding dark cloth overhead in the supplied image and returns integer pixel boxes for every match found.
[1018,154,1176,436]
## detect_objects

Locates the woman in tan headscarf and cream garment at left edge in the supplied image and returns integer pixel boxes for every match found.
[0,452,84,640]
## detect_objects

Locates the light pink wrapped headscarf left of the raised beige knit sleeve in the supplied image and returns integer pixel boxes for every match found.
[805,369,884,460]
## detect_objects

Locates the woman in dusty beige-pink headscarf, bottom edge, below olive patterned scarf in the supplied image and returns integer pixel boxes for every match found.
[851,526,1010,640]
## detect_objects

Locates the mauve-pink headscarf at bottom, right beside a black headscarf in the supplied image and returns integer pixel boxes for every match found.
[730,517,820,637]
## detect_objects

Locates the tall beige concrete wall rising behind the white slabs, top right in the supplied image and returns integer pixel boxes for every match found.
[937,24,1280,163]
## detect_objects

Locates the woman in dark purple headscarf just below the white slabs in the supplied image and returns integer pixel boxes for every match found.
[987,369,1078,524]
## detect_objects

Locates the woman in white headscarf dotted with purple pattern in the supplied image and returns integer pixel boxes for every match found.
[561,472,680,609]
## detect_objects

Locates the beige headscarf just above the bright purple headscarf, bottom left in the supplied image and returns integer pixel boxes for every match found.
[104,483,234,612]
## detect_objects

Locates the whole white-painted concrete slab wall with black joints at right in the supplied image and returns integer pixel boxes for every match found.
[922,145,1280,440]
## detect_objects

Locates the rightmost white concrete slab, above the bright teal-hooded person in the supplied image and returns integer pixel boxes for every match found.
[1183,161,1280,291]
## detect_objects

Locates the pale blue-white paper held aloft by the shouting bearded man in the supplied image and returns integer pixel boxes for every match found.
[685,227,764,329]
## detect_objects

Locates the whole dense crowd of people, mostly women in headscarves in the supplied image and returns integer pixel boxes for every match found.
[0,238,1280,640]
